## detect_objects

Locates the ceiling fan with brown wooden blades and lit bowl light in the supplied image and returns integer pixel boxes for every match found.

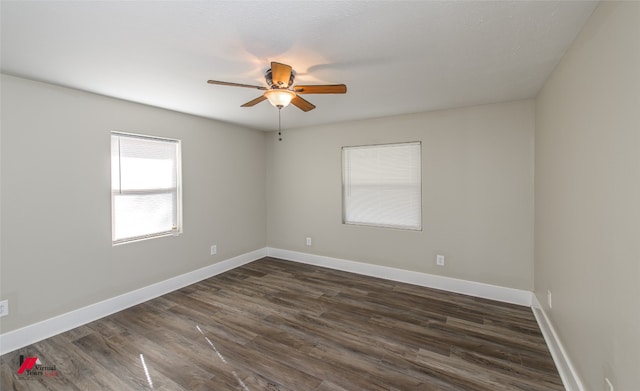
[207,62,347,111]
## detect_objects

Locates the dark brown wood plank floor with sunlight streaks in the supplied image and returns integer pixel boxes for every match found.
[0,258,564,391]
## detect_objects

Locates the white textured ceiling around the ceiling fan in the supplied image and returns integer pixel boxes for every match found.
[0,1,597,130]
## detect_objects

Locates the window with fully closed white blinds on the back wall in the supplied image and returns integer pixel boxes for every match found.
[342,142,422,230]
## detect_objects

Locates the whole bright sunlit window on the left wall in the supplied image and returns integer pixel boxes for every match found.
[111,132,182,244]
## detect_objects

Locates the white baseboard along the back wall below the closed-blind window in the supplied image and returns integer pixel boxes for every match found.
[267,247,532,307]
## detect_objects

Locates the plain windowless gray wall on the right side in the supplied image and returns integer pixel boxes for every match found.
[535,2,640,390]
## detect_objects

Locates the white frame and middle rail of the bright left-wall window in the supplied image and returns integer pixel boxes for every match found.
[110,131,183,246]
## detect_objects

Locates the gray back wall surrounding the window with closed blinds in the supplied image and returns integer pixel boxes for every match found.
[267,101,534,290]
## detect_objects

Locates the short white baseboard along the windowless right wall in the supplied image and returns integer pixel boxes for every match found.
[531,294,586,391]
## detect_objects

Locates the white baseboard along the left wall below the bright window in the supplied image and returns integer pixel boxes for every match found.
[0,248,267,355]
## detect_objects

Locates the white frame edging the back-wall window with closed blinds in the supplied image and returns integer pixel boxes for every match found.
[341,141,423,232]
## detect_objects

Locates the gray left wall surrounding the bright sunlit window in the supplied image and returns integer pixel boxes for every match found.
[0,75,266,333]
